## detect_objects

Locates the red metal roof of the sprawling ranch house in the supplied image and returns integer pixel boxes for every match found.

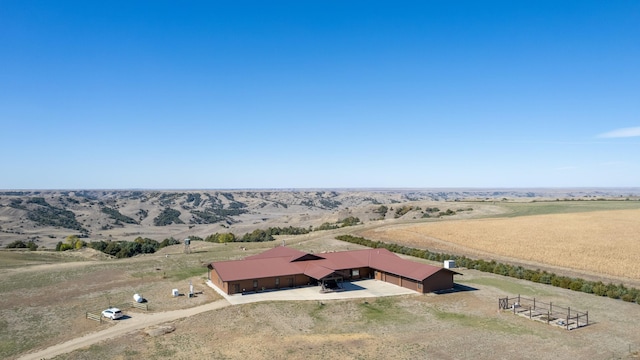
[210,246,458,281]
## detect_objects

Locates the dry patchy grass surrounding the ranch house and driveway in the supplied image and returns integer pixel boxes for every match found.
[0,234,640,360]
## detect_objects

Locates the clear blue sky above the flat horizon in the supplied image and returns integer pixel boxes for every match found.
[0,0,640,189]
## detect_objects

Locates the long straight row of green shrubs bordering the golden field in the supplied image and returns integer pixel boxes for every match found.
[336,235,640,304]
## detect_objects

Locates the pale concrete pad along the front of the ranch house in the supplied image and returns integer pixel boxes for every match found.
[207,279,420,305]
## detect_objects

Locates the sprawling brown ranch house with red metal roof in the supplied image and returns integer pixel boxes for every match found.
[208,246,459,295]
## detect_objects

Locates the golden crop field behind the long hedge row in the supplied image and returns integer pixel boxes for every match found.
[362,210,640,280]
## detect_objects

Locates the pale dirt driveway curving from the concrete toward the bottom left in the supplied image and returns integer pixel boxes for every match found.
[18,299,231,360]
